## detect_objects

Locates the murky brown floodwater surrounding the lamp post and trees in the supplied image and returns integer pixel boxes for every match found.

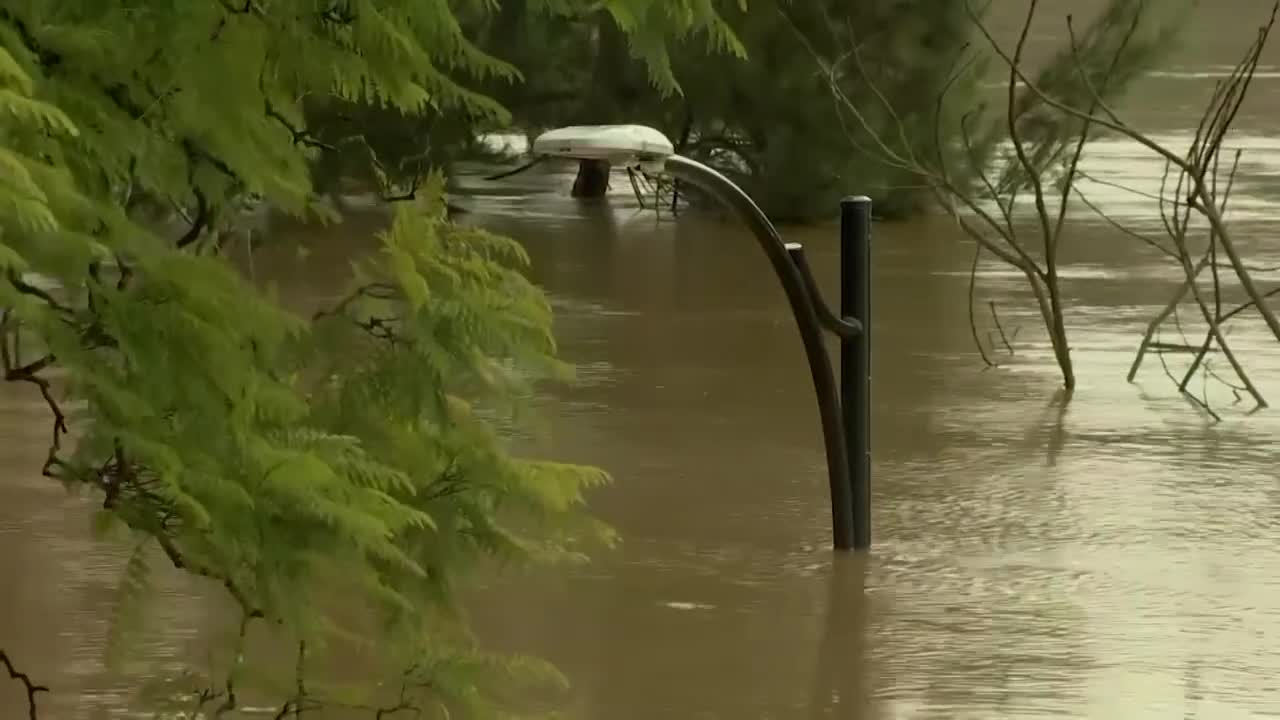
[0,0,1280,720]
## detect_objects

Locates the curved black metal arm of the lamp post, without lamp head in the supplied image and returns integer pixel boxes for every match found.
[666,155,856,550]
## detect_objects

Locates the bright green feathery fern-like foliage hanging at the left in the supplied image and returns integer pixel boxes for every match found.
[0,0,733,716]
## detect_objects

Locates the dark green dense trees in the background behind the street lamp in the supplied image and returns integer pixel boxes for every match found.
[394,0,975,222]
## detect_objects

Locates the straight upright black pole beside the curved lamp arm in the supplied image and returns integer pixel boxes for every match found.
[840,196,872,550]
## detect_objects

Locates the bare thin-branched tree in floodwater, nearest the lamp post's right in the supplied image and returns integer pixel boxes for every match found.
[792,0,1179,389]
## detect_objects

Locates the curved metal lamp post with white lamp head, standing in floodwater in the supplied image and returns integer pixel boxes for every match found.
[532,126,870,550]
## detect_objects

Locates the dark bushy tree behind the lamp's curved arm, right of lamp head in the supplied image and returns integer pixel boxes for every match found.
[669,0,978,222]
